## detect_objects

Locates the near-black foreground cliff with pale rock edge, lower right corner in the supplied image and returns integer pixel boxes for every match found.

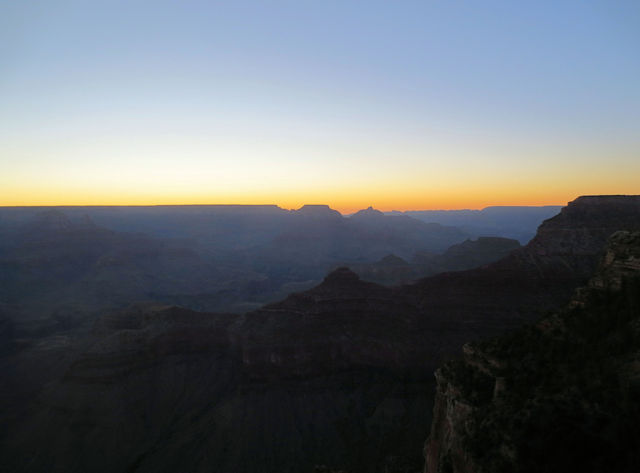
[425,232,640,473]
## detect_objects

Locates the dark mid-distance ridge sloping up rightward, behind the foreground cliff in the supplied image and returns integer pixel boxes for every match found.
[0,197,640,473]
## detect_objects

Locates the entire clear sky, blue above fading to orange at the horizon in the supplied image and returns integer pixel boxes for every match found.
[0,0,640,212]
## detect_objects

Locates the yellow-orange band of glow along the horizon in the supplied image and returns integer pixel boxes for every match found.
[0,169,640,214]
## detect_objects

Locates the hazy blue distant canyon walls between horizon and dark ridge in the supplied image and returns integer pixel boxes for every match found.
[0,205,466,332]
